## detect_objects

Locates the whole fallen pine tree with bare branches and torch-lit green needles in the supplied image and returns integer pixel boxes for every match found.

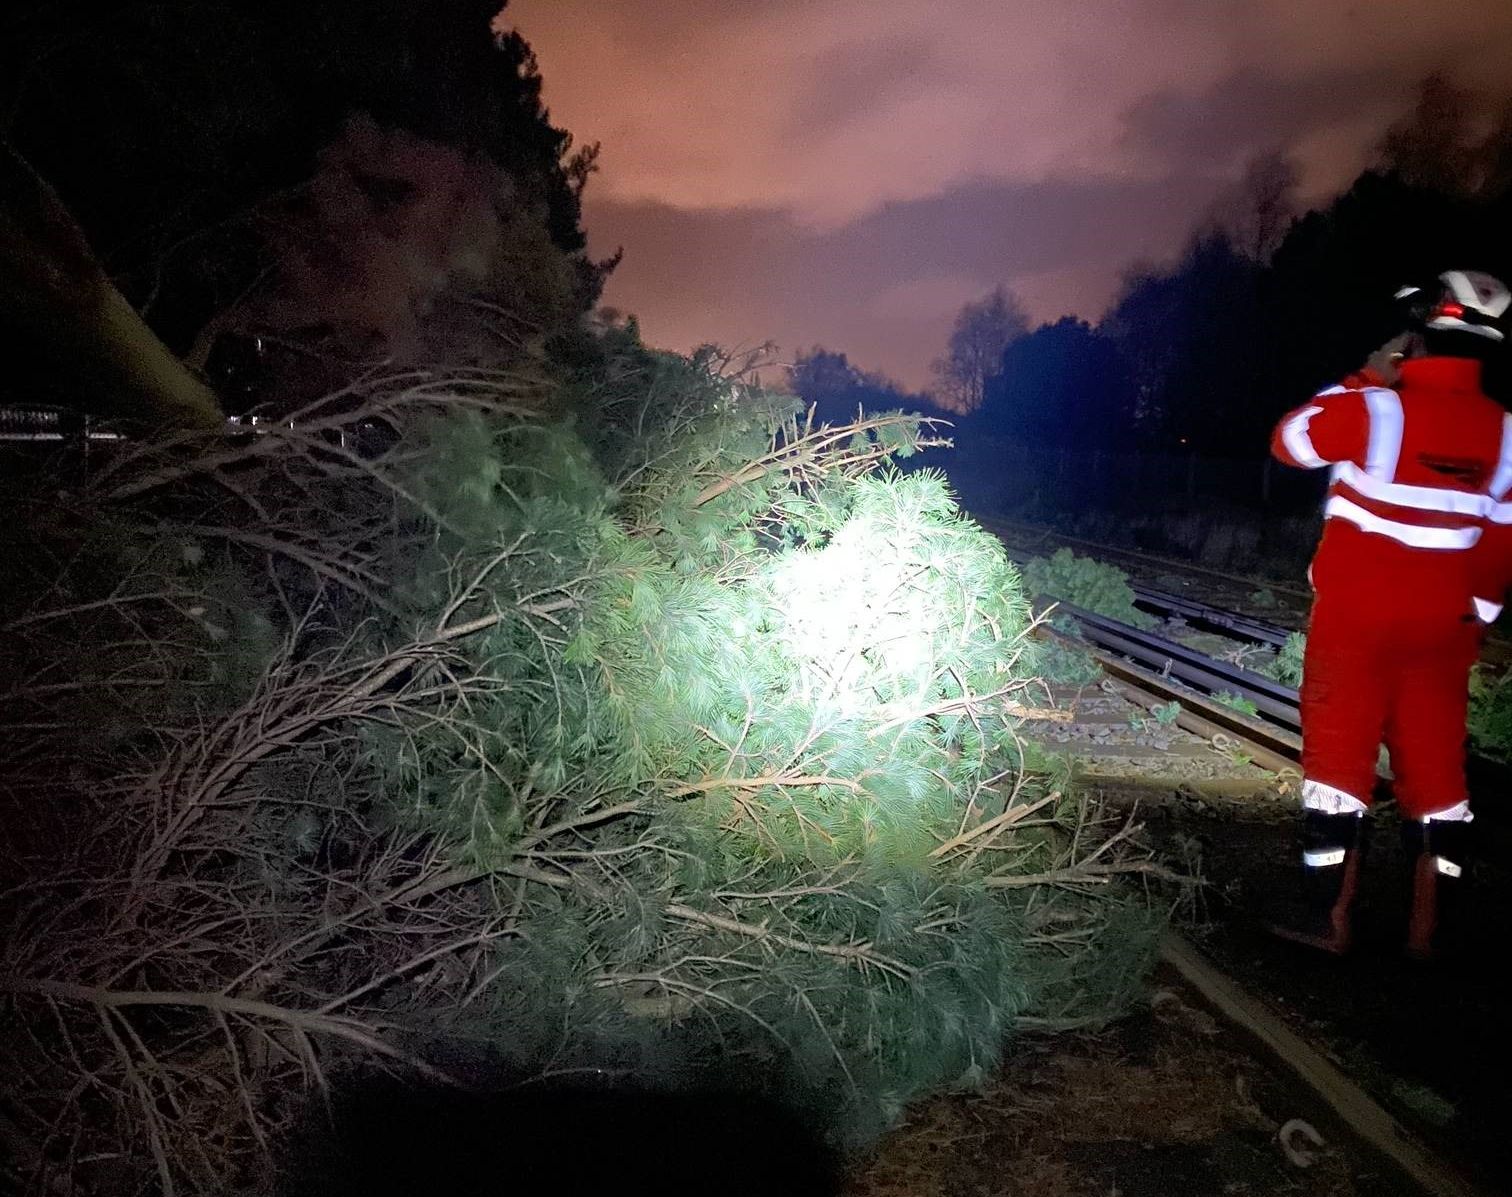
[0,331,1173,1192]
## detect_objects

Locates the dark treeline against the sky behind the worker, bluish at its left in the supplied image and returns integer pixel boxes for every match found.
[794,77,1512,458]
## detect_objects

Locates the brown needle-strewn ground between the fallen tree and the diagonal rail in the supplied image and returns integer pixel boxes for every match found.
[847,973,1412,1197]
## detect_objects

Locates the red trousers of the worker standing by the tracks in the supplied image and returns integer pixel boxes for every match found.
[1302,594,1479,819]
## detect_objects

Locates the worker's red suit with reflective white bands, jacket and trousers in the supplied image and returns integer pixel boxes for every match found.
[1272,357,1512,822]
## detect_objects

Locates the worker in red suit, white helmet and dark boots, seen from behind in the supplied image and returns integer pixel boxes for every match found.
[1272,271,1512,958]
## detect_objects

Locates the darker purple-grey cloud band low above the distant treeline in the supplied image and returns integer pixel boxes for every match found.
[587,174,1226,387]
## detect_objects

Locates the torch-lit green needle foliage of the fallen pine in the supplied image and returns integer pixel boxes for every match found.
[362,343,1154,1141]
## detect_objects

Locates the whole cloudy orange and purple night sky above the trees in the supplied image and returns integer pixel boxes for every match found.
[507,0,1512,385]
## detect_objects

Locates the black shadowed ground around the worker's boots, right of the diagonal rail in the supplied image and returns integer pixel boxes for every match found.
[1146,806,1512,1192]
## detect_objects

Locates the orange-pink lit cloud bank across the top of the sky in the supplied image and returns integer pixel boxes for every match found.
[507,0,1512,217]
